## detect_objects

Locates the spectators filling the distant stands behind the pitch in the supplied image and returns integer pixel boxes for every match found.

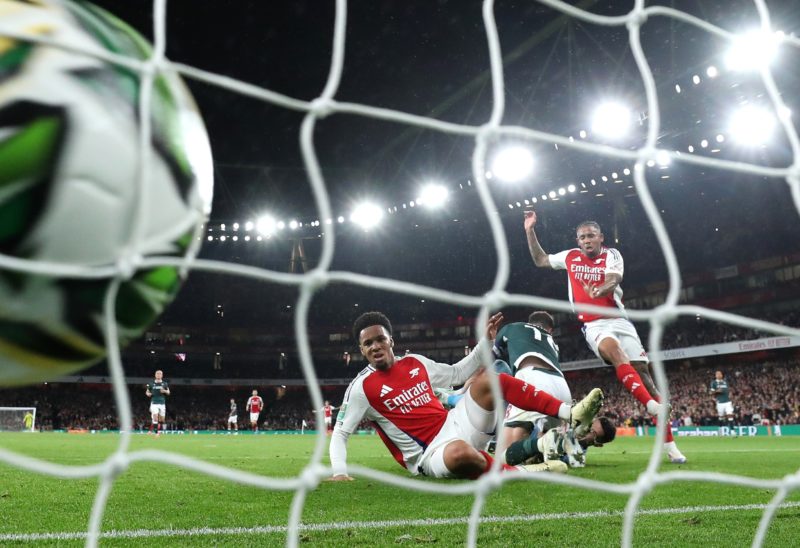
[0,358,800,430]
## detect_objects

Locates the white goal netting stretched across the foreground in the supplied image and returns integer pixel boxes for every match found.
[0,0,800,547]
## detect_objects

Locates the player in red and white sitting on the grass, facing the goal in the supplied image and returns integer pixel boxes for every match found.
[330,312,603,481]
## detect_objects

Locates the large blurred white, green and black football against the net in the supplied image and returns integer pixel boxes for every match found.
[0,0,213,386]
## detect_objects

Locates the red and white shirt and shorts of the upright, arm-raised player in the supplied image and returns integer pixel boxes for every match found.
[548,247,650,363]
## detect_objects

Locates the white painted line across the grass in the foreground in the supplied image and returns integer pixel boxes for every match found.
[0,502,800,542]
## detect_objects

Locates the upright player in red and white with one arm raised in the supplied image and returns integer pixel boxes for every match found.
[524,211,686,464]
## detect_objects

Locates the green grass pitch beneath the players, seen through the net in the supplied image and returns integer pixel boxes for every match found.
[0,433,800,548]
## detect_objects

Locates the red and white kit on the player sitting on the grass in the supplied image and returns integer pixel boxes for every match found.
[330,342,494,477]
